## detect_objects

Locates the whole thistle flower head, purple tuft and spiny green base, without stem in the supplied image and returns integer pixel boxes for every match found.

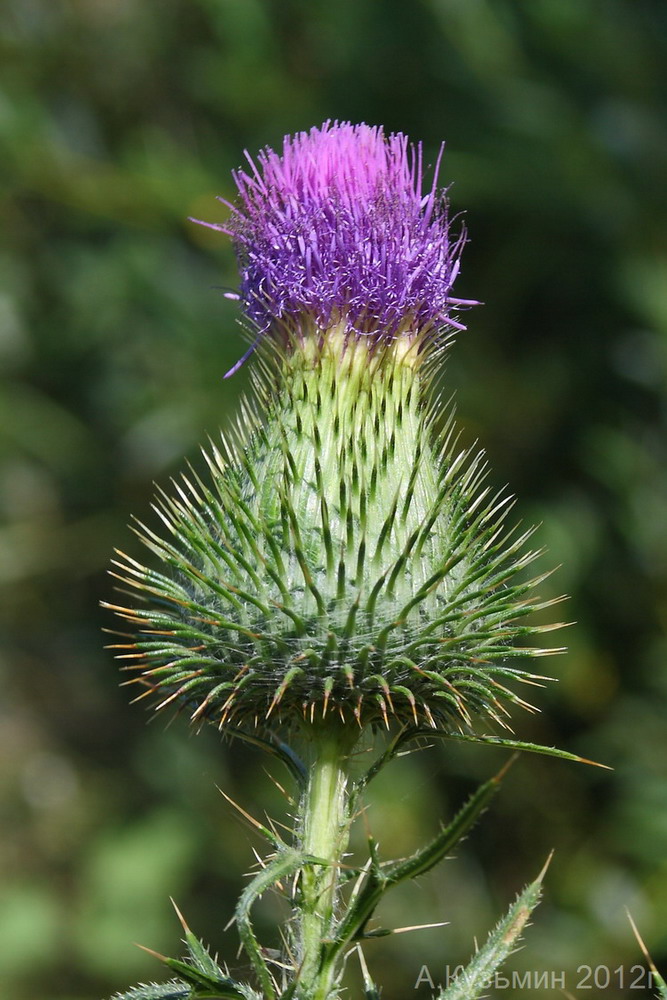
[107,124,560,730]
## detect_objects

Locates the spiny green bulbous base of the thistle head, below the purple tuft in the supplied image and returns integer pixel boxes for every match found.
[109,329,560,730]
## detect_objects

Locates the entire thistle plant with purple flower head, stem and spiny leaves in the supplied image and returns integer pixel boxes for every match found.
[104,123,572,1000]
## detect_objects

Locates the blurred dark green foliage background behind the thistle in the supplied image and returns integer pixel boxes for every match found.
[0,0,667,1000]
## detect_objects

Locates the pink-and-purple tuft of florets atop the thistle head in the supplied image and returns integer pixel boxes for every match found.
[196,122,474,356]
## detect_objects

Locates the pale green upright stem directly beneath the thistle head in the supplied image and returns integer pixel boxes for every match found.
[297,727,358,1000]
